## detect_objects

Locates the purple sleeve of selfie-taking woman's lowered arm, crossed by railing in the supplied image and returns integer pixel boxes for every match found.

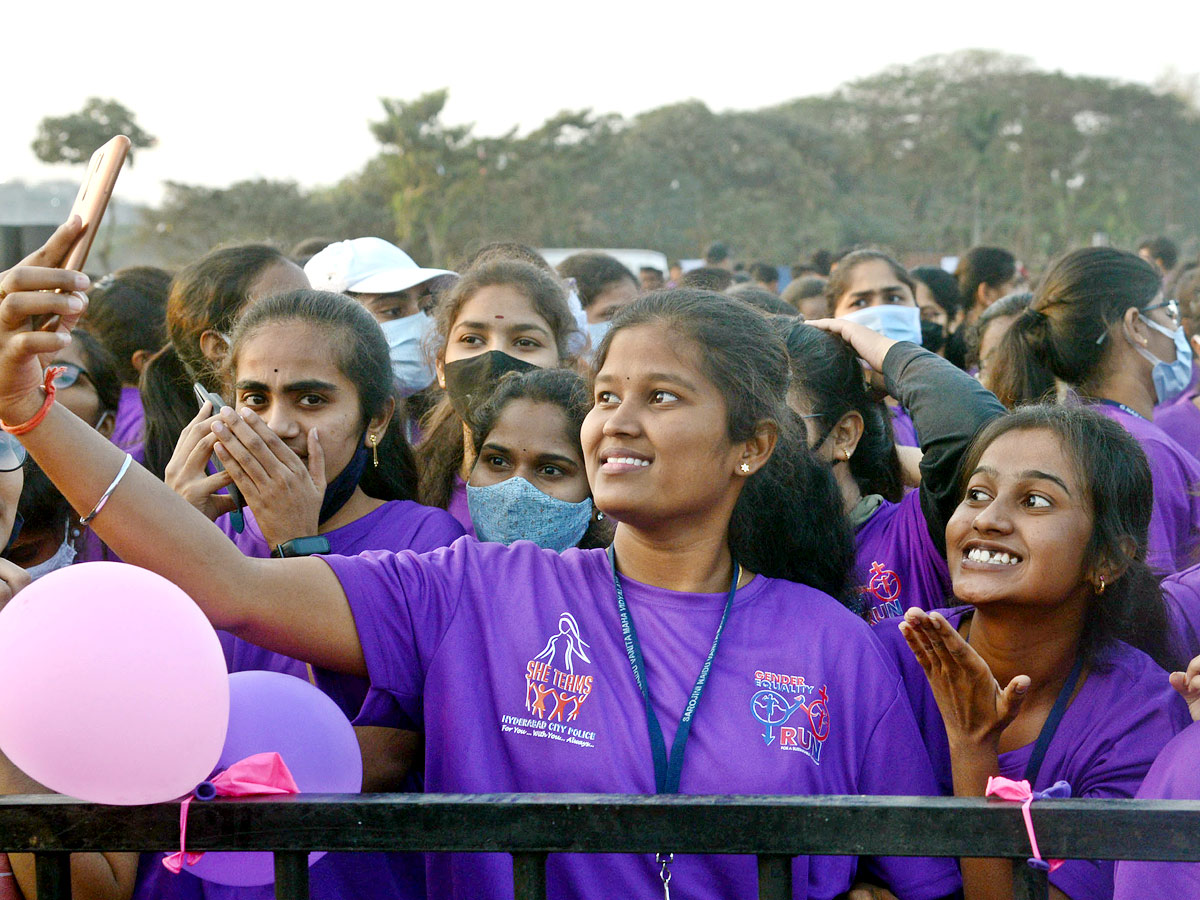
[858,679,961,900]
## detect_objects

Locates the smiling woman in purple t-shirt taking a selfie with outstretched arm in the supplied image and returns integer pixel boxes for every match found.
[0,222,958,900]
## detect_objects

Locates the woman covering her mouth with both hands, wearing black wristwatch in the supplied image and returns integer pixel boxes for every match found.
[156,290,463,900]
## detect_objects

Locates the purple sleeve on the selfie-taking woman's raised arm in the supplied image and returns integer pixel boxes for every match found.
[322,540,472,731]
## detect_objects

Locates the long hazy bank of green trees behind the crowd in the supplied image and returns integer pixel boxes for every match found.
[133,50,1200,265]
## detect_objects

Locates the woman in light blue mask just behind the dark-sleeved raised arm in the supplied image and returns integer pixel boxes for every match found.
[824,250,920,446]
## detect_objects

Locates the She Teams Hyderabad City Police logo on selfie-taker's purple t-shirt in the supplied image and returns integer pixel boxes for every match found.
[500,612,596,746]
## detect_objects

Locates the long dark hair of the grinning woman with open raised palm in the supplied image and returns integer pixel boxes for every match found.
[959,404,1183,672]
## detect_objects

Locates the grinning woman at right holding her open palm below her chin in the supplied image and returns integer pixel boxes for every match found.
[878,407,1189,900]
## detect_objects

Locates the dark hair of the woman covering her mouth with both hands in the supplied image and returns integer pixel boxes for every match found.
[223,290,416,500]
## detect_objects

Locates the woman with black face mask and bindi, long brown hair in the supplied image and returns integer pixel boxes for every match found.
[416,259,578,534]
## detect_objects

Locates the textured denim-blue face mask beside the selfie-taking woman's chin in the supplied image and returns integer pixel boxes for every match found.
[467,475,592,553]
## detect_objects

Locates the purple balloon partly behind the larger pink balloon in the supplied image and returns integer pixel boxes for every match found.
[184,672,362,887]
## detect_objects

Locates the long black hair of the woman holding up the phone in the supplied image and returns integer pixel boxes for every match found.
[593,288,857,608]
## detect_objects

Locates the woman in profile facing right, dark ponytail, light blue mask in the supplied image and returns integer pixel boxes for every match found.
[991,247,1200,574]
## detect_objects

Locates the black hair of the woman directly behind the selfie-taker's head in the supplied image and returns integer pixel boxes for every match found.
[774,319,904,503]
